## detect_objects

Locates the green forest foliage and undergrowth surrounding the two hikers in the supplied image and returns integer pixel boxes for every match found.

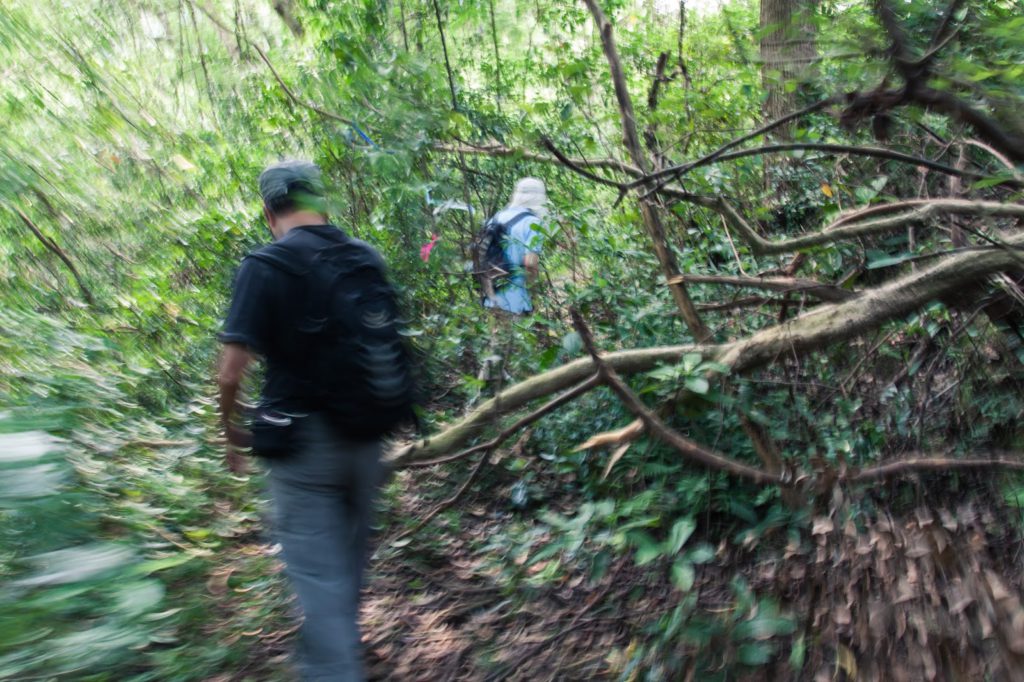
[0,0,1024,681]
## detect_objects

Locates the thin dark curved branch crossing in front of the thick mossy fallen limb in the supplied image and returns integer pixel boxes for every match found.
[569,308,782,484]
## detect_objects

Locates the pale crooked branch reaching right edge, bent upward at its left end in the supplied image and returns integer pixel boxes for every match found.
[717,199,1024,255]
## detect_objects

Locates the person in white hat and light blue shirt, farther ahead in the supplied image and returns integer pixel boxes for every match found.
[483,177,548,314]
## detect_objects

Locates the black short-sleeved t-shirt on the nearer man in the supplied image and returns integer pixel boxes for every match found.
[217,225,341,409]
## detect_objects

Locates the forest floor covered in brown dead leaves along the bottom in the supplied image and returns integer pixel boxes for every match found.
[206,456,1024,681]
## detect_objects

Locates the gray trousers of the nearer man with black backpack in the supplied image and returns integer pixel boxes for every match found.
[267,414,381,682]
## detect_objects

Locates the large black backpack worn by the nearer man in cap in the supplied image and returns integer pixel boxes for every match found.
[252,229,416,439]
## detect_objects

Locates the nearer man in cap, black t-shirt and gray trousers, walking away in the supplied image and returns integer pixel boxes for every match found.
[218,161,411,682]
